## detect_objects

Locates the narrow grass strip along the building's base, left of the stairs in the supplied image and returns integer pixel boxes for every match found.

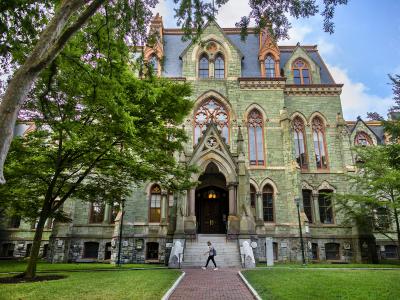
[0,260,165,273]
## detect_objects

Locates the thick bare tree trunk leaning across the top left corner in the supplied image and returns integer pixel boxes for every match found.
[0,0,105,184]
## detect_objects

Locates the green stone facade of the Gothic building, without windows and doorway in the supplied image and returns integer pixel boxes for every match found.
[0,18,396,262]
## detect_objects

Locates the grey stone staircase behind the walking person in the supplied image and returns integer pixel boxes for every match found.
[182,234,241,267]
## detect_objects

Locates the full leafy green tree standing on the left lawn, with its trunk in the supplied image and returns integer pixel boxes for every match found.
[0,14,192,278]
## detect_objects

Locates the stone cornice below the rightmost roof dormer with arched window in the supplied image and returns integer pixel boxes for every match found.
[284,84,343,96]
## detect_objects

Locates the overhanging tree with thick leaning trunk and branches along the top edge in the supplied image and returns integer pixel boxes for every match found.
[0,0,347,184]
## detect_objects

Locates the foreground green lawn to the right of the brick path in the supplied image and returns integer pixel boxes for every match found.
[243,269,400,300]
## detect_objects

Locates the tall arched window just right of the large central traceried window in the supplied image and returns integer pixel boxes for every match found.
[247,109,264,166]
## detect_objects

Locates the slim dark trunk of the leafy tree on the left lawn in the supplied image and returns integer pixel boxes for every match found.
[19,210,48,279]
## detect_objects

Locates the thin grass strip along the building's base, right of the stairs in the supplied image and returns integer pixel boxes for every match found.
[257,261,400,268]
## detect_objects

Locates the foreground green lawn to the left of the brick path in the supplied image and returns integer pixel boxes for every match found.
[0,269,181,300]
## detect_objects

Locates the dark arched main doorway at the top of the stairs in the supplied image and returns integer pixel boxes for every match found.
[196,162,229,234]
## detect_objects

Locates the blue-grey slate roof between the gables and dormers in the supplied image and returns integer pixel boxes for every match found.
[163,29,335,84]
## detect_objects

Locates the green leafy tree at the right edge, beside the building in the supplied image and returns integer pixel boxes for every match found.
[338,75,400,258]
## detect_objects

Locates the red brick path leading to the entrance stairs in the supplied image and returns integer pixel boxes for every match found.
[169,268,254,300]
